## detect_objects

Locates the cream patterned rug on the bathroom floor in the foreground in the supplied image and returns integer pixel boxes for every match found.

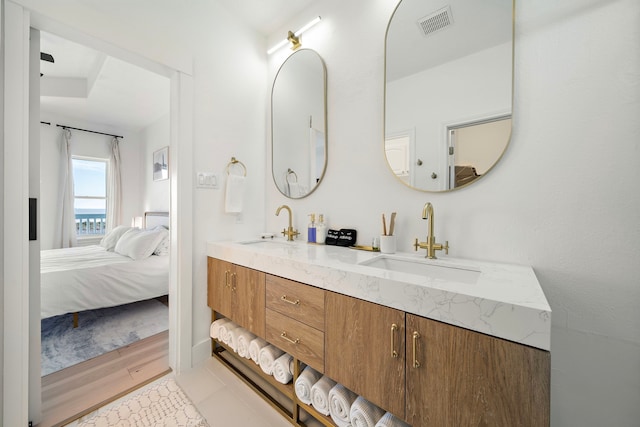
[78,378,209,427]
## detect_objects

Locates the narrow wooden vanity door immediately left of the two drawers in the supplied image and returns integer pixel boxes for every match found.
[230,265,265,338]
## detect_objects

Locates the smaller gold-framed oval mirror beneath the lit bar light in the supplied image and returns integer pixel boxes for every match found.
[271,49,327,199]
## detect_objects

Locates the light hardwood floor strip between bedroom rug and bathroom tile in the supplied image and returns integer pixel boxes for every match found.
[36,331,170,427]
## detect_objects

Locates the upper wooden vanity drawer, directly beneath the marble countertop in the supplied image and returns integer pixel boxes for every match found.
[266,275,324,331]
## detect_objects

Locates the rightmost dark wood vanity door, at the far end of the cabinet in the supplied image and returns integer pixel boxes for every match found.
[406,314,550,427]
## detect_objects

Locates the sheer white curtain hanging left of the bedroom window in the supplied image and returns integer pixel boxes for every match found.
[54,129,76,248]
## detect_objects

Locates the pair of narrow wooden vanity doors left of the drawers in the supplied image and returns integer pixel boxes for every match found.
[207,258,266,338]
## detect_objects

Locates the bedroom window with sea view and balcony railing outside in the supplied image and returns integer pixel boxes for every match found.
[71,157,108,236]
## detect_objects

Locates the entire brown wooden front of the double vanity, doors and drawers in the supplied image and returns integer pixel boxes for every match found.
[208,258,550,427]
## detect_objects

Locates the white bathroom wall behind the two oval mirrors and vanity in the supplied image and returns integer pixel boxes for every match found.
[265,0,640,427]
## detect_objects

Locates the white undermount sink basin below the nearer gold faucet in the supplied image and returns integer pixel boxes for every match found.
[359,255,480,284]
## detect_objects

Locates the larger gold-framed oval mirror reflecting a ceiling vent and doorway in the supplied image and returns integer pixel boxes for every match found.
[384,0,514,191]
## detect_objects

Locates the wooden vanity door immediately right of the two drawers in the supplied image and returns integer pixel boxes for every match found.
[325,292,404,418]
